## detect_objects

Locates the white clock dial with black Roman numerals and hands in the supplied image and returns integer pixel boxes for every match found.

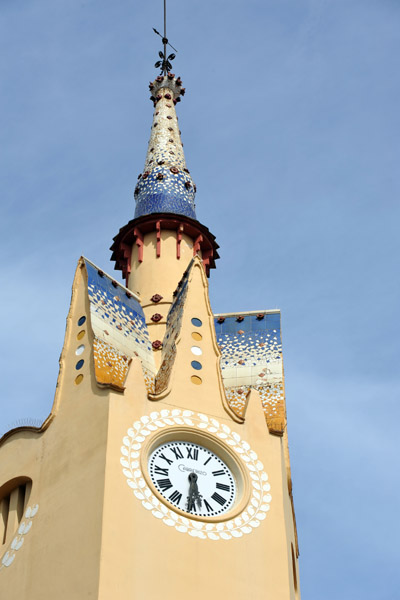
[148,441,236,517]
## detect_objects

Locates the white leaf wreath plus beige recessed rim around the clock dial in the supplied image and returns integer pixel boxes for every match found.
[120,409,271,540]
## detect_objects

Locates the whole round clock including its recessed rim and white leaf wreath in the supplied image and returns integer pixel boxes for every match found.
[120,408,271,540]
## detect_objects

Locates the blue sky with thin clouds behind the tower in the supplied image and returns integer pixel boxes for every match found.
[0,0,400,600]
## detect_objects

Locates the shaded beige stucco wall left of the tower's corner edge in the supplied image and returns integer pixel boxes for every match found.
[0,264,109,600]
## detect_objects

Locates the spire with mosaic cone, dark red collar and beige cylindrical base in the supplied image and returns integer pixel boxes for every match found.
[111,5,219,286]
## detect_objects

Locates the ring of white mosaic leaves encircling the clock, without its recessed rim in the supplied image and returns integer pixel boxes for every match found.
[120,409,271,540]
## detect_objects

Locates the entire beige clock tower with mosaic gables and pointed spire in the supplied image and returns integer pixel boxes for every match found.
[0,35,300,600]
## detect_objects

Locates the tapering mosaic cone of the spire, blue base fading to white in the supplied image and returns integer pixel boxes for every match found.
[135,73,196,219]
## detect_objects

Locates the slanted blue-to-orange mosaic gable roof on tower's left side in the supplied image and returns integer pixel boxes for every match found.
[84,259,155,392]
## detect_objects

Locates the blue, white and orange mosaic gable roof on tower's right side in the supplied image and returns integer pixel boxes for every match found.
[215,311,286,434]
